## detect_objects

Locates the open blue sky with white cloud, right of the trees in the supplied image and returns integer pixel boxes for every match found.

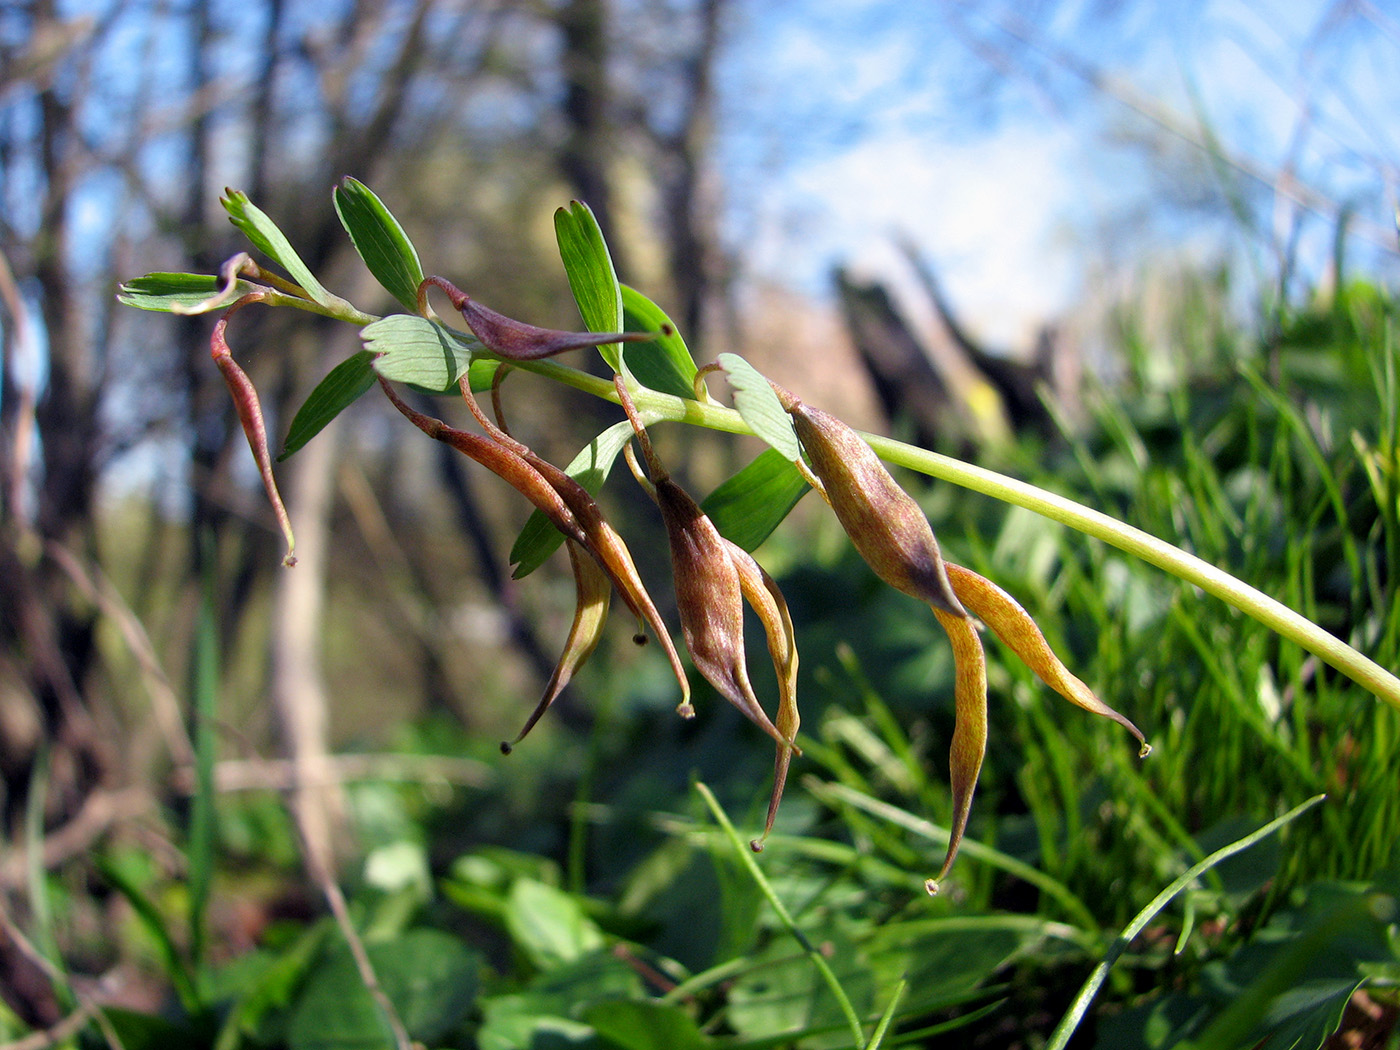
[724,0,1400,346]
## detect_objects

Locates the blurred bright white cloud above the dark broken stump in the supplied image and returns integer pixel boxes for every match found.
[755,125,1082,346]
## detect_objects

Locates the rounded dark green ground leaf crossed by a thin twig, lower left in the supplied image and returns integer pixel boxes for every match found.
[287,930,480,1050]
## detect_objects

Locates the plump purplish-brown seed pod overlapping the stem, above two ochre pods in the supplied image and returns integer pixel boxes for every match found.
[774,385,967,616]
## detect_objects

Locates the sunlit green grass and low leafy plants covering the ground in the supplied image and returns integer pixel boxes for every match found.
[0,186,1400,1050]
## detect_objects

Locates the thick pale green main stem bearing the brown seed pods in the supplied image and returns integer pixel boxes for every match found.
[519,361,1400,711]
